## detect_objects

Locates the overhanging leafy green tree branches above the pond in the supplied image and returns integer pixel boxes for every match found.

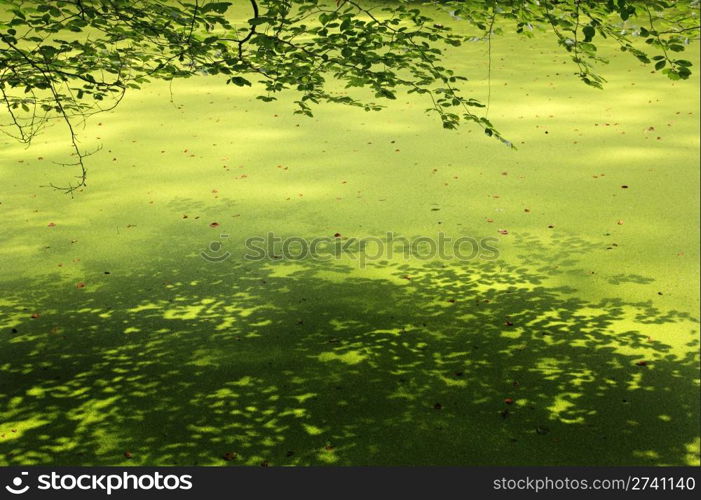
[0,0,699,193]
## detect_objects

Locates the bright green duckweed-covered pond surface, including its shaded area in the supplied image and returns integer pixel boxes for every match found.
[0,5,699,465]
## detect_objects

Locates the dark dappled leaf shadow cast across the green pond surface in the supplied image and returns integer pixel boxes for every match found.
[0,235,699,465]
